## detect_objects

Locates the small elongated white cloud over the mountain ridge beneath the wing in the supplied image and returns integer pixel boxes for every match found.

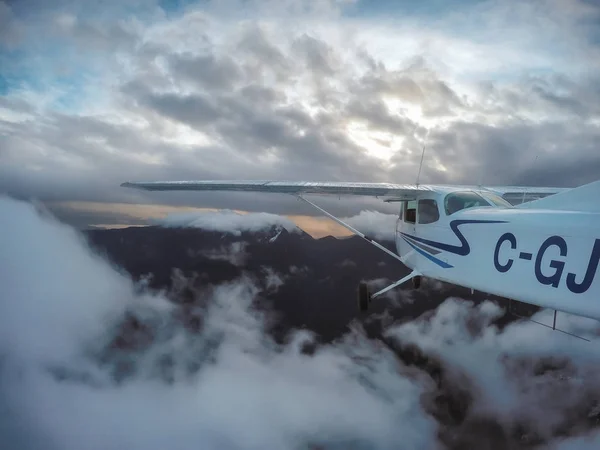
[154,210,300,236]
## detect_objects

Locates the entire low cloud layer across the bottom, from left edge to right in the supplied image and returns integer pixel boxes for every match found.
[0,198,600,450]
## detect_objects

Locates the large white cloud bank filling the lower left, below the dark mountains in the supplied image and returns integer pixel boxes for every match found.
[0,198,436,449]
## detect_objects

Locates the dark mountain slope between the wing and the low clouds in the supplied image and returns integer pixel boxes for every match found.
[86,226,506,341]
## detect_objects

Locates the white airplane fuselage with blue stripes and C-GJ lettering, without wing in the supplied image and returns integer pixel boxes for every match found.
[396,192,600,319]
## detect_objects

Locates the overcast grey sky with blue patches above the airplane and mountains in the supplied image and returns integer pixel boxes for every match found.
[0,0,600,230]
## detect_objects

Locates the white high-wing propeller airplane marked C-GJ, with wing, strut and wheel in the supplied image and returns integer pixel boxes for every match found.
[121,180,600,331]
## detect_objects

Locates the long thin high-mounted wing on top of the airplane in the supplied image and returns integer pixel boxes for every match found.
[121,180,567,203]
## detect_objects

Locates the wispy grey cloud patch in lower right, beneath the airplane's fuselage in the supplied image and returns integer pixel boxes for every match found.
[387,298,600,448]
